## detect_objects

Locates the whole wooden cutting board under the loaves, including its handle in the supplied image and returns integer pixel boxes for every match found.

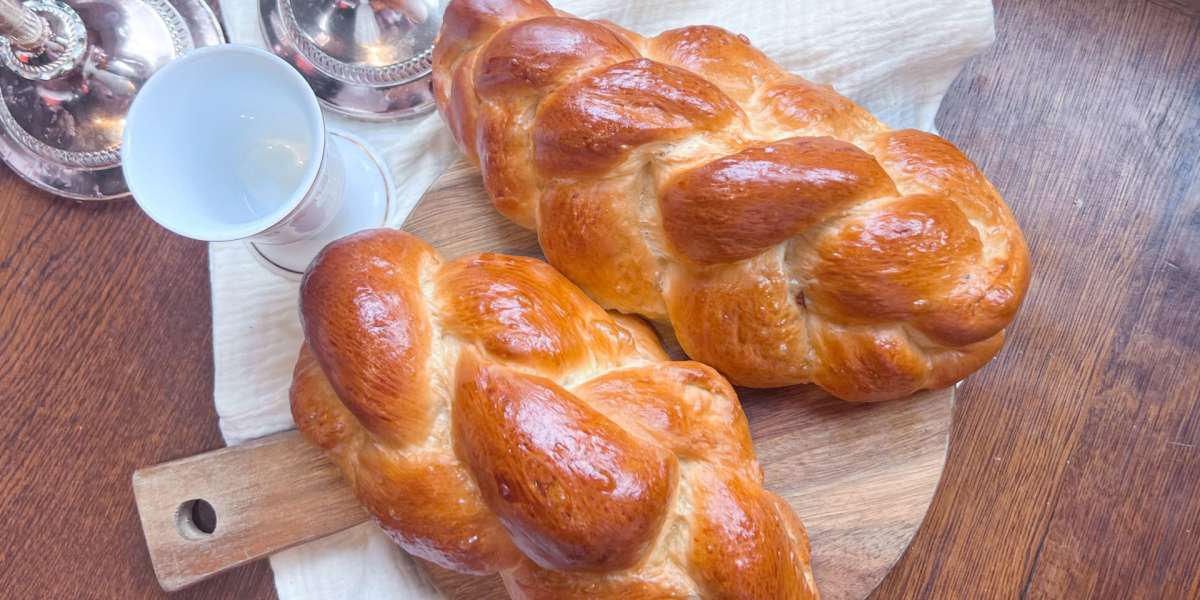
[133,162,954,600]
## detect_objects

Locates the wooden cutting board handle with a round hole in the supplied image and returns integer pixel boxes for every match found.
[133,431,367,592]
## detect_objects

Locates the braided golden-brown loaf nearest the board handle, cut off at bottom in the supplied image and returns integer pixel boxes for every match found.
[292,229,817,599]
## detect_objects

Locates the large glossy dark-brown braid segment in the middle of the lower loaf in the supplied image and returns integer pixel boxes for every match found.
[451,352,677,571]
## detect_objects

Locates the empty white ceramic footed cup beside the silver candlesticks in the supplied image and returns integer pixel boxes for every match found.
[121,44,391,275]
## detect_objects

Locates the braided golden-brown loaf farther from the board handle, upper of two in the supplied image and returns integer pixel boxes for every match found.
[433,0,1028,401]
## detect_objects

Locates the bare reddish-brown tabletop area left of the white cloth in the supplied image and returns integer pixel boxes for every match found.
[0,193,274,599]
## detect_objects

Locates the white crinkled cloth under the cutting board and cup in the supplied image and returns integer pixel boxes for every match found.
[209,0,994,600]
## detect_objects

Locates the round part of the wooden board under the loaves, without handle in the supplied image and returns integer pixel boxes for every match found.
[403,161,954,600]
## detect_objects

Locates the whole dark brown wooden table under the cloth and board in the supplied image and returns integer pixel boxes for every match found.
[0,0,1200,598]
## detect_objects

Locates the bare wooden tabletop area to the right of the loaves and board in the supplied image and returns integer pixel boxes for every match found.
[877,0,1200,599]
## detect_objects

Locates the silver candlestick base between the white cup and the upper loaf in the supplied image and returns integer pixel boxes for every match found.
[259,0,442,120]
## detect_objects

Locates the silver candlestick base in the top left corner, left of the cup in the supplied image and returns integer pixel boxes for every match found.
[0,0,224,200]
